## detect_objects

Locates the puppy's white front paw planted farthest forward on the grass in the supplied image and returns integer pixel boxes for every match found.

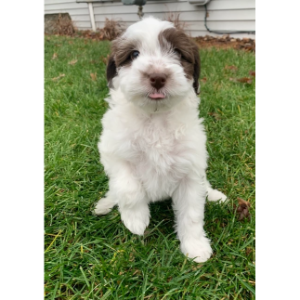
[181,237,213,263]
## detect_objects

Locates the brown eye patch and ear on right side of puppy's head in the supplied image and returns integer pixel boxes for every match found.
[158,28,200,94]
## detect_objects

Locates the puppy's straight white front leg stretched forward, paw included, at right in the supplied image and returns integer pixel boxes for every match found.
[173,178,212,263]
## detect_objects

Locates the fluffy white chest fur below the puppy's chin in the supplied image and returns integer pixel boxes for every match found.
[100,99,207,201]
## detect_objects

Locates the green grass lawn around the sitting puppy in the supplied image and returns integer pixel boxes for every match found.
[43,37,256,300]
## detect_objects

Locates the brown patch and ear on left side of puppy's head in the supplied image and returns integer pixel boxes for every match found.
[106,37,137,87]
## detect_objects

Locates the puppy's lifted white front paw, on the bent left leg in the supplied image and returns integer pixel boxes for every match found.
[121,207,150,235]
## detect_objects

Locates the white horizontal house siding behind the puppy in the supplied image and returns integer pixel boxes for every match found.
[43,0,256,38]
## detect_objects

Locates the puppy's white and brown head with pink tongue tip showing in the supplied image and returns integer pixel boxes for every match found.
[107,17,200,110]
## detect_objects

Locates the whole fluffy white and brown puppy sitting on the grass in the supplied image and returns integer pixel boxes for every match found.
[95,17,226,262]
